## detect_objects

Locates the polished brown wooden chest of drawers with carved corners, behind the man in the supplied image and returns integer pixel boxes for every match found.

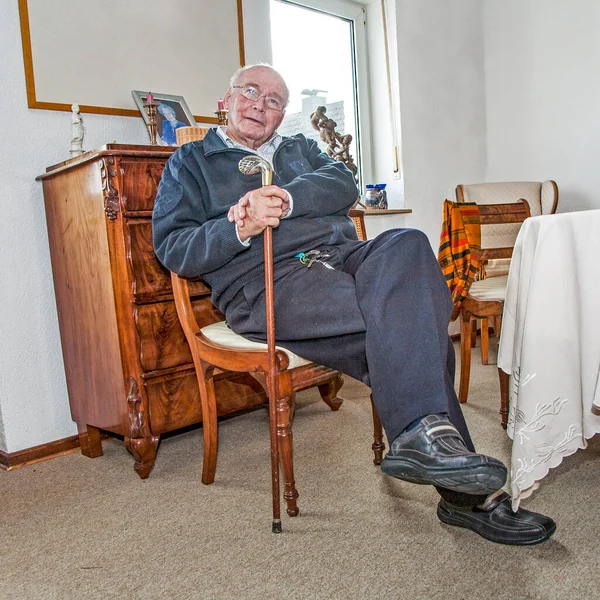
[38,144,265,478]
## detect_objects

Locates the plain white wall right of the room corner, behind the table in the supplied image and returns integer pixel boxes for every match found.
[483,0,600,212]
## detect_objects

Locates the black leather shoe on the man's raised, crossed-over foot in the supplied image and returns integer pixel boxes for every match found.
[381,415,506,495]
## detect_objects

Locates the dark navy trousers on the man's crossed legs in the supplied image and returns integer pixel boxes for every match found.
[226,229,490,505]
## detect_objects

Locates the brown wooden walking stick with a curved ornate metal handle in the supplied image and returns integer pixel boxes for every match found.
[238,155,281,533]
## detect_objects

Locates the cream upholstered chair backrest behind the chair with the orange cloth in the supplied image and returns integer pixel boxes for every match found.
[456,180,558,248]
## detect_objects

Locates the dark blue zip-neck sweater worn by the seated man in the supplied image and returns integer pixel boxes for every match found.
[152,129,358,313]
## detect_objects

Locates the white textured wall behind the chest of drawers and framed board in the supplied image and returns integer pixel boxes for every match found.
[0,0,271,452]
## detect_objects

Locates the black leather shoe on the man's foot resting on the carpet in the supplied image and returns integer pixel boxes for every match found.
[437,492,556,546]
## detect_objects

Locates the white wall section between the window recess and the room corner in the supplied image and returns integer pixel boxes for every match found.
[396,0,486,245]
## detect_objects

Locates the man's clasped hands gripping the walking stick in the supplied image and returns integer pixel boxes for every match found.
[227,185,290,242]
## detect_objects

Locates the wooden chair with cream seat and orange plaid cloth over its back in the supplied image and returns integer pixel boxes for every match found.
[458,199,531,429]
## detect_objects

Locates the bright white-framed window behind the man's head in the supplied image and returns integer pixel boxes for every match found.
[270,0,367,188]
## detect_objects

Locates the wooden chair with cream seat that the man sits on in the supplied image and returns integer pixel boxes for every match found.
[171,212,384,531]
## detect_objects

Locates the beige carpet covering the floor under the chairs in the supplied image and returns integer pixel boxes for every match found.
[0,342,600,600]
